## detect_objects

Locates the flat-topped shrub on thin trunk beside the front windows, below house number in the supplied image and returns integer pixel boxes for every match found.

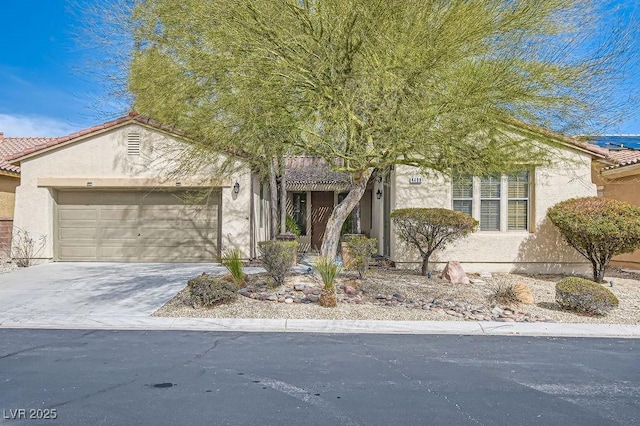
[391,208,478,276]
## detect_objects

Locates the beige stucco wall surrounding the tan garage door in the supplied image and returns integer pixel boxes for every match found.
[14,124,252,258]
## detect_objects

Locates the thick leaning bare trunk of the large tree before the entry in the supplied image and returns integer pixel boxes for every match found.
[320,168,373,259]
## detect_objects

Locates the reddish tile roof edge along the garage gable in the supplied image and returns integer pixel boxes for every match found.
[5,112,182,163]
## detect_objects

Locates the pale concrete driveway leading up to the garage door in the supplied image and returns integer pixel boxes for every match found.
[0,263,225,320]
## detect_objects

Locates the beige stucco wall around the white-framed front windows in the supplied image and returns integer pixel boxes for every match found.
[384,146,596,273]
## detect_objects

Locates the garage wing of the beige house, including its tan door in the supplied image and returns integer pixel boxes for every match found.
[9,113,268,262]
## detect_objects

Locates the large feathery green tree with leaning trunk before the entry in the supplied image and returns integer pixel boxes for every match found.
[119,0,636,256]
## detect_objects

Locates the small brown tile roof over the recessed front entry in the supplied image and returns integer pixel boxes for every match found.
[285,155,352,190]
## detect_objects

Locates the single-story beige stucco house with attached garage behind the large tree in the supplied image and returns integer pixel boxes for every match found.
[5,113,605,272]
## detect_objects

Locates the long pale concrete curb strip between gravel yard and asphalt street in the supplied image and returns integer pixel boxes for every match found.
[0,317,640,339]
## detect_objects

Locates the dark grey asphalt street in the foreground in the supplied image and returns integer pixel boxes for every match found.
[0,329,640,426]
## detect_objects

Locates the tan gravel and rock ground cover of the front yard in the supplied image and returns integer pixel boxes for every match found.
[153,268,640,325]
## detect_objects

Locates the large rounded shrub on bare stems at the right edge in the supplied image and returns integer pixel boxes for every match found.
[547,197,640,282]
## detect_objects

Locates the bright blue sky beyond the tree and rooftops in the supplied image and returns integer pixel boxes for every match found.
[0,0,640,136]
